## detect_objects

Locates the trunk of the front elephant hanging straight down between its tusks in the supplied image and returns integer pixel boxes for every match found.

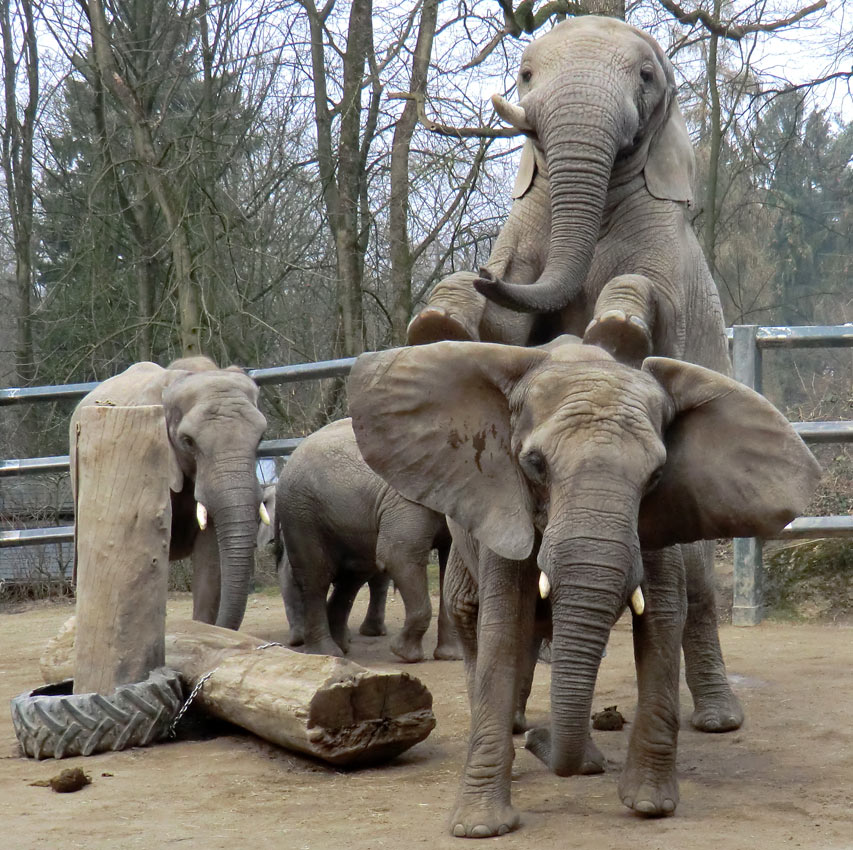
[549,538,628,776]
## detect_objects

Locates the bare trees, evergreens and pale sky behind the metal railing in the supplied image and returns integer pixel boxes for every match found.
[0,0,853,556]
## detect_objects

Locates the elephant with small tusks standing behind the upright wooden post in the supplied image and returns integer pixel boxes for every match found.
[70,357,266,629]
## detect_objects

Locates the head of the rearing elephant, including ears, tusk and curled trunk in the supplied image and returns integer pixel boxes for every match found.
[475,16,694,312]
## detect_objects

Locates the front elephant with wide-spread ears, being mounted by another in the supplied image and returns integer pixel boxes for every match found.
[349,341,819,837]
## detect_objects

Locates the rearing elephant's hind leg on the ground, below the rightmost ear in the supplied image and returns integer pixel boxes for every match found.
[681,541,743,732]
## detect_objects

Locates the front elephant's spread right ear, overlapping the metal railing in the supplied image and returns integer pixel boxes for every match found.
[639,357,820,548]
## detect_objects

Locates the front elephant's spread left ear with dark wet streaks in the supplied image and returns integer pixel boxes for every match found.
[348,342,548,560]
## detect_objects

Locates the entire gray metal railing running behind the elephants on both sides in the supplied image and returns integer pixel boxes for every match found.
[0,324,853,626]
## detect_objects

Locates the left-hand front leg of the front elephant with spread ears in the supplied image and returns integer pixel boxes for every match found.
[450,552,536,838]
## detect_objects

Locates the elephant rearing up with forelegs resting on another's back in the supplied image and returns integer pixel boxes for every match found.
[409,16,743,732]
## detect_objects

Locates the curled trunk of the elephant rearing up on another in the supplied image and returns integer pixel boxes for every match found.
[476,80,623,313]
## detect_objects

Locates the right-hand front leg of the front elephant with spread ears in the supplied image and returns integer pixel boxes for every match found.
[619,547,687,816]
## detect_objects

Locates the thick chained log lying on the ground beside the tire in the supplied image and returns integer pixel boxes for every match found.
[40,620,435,767]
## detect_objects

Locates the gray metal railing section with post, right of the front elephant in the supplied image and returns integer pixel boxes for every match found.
[728,324,853,626]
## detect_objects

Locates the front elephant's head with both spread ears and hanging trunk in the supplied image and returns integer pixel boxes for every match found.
[349,342,819,775]
